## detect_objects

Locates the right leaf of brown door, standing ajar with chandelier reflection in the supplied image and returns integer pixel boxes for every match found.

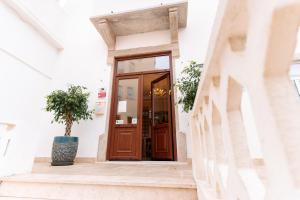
[151,73,173,160]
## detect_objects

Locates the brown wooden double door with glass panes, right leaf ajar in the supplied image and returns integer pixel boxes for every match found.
[108,72,174,160]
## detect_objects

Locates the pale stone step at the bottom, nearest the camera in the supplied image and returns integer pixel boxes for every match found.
[0,174,197,200]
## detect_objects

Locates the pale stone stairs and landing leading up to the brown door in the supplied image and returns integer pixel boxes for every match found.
[0,163,197,200]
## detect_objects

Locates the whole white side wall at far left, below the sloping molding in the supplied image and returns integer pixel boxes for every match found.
[0,2,58,175]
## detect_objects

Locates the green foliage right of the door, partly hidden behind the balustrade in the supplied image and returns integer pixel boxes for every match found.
[175,61,203,113]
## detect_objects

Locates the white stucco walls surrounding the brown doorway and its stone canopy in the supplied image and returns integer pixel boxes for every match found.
[0,0,218,169]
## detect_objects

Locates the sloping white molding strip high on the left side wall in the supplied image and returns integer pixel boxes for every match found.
[3,0,64,51]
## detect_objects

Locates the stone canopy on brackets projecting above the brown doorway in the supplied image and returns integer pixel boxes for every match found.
[90,1,188,36]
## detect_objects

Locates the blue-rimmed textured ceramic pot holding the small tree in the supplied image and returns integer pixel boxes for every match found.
[51,136,78,166]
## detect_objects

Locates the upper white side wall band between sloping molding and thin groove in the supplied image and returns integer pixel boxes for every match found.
[0,0,58,76]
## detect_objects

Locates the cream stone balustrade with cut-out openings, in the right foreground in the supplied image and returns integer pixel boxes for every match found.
[190,0,300,200]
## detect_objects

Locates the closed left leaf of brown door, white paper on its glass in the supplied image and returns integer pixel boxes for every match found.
[109,76,142,160]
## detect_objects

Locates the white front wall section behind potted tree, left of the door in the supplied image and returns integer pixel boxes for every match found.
[36,0,110,158]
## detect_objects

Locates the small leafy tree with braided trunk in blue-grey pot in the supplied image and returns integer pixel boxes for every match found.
[46,85,93,166]
